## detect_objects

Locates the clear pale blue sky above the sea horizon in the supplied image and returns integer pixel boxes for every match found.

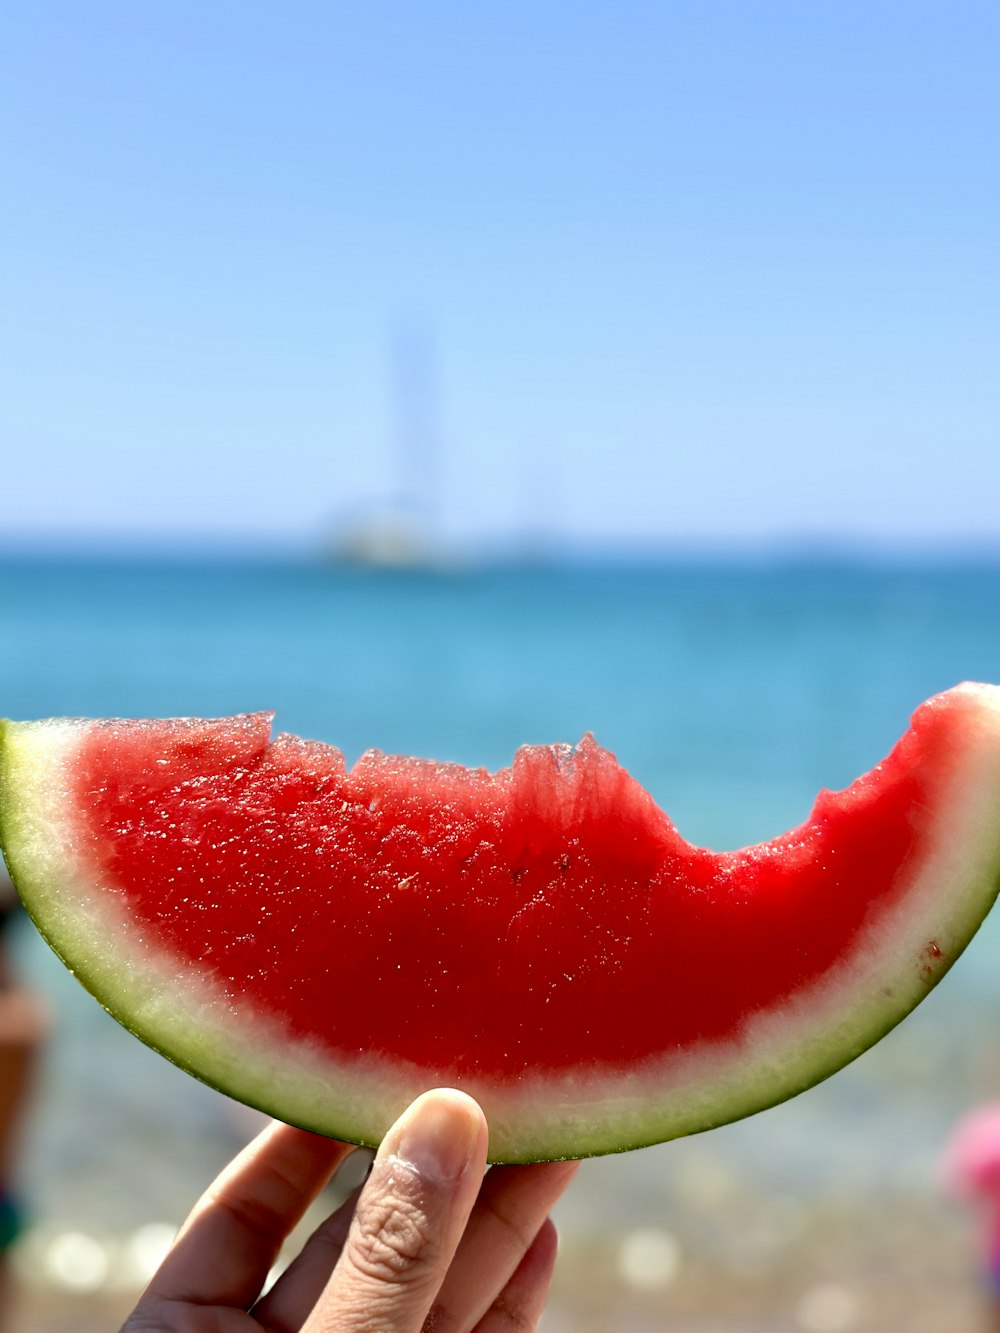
[0,0,1000,545]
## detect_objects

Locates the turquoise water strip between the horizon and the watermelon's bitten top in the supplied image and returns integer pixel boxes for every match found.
[7,551,1000,844]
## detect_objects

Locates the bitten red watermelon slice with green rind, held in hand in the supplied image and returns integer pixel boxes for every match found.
[0,685,1000,1161]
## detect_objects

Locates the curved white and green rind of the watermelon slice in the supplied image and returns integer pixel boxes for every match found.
[0,686,1000,1161]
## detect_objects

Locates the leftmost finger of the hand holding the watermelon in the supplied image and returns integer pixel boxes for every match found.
[140,1121,353,1308]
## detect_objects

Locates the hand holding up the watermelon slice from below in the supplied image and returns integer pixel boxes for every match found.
[121,1089,579,1333]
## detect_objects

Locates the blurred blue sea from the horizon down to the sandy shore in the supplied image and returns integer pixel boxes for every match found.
[0,556,1000,1301]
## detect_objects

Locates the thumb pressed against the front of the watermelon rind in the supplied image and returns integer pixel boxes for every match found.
[303,1089,487,1333]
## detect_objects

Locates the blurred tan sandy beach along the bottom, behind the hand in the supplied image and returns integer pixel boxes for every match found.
[5,1198,985,1333]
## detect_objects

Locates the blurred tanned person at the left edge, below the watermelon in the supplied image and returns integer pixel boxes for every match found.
[0,861,48,1333]
